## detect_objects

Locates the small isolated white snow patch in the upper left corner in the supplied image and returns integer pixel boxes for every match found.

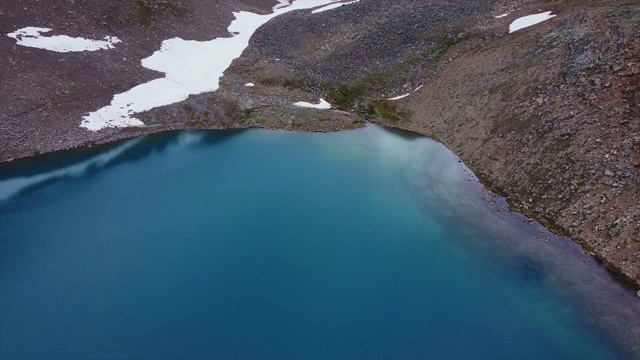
[7,27,120,52]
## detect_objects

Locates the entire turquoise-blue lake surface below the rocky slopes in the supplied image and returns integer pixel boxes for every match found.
[0,126,640,359]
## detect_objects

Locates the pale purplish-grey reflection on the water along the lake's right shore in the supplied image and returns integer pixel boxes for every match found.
[328,127,640,359]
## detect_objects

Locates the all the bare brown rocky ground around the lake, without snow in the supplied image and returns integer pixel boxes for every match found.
[0,0,640,290]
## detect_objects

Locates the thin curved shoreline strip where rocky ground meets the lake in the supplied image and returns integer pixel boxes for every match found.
[0,121,640,294]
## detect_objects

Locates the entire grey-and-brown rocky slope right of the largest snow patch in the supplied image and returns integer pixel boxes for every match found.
[219,0,640,289]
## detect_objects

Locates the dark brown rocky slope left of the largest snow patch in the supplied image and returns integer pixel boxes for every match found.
[0,0,277,161]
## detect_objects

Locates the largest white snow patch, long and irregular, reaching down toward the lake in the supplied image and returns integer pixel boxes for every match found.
[80,0,337,131]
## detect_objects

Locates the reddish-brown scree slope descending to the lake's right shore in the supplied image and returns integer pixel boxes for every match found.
[400,3,640,284]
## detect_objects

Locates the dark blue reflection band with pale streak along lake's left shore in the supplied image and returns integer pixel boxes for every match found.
[0,130,244,203]
